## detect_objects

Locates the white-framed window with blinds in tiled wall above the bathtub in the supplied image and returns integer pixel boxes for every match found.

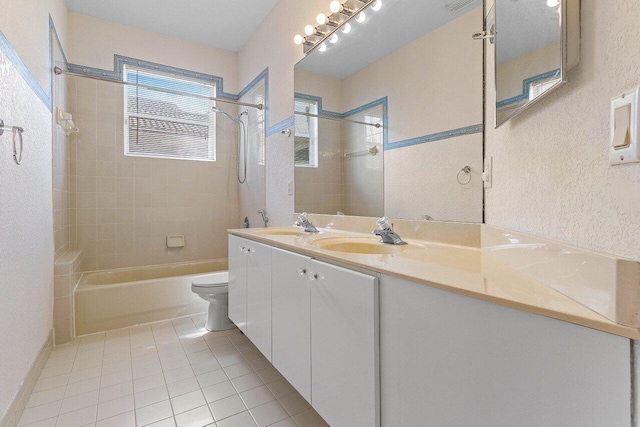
[124,67,216,161]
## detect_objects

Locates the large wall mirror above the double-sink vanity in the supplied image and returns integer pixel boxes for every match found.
[294,0,483,222]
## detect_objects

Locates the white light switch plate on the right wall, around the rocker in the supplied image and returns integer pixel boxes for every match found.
[609,87,640,165]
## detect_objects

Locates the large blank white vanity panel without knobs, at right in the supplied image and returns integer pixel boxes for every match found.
[380,276,631,427]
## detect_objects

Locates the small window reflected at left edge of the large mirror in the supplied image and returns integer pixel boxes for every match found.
[294,98,318,168]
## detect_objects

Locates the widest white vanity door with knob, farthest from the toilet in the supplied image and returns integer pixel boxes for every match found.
[309,260,380,427]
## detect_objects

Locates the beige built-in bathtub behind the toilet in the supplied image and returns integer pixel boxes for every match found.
[74,259,227,335]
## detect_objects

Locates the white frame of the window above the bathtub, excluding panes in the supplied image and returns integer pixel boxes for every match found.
[122,65,217,162]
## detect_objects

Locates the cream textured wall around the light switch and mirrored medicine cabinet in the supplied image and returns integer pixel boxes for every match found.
[485,0,640,260]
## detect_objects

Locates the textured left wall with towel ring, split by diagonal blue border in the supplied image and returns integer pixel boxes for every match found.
[0,0,66,418]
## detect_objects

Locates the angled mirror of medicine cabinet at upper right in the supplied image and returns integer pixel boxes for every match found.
[495,0,580,127]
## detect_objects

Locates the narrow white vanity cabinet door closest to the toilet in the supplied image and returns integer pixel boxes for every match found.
[229,235,248,334]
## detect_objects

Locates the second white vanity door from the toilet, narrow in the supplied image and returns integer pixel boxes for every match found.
[246,241,272,361]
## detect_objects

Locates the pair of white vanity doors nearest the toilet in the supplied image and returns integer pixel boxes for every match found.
[229,236,272,361]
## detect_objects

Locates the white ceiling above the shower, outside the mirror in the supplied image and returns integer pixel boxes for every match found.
[66,0,278,52]
